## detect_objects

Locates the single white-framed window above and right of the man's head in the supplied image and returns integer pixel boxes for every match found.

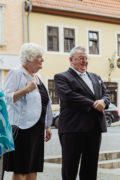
[88,31,99,54]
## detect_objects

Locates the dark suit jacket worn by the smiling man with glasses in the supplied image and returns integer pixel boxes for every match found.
[54,68,110,133]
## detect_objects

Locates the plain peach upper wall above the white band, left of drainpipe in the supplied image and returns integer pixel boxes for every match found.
[0,0,23,54]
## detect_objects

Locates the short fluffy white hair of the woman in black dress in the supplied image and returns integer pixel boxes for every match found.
[20,43,45,65]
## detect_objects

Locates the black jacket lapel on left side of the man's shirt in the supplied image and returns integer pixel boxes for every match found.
[68,68,95,97]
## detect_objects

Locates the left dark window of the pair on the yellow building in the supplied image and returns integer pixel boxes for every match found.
[47,26,59,51]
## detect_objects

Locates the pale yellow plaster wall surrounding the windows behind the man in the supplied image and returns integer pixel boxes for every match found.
[30,13,120,81]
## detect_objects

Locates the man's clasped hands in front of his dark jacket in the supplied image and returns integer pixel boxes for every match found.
[93,99,106,113]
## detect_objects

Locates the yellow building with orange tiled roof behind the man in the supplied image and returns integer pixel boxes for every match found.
[26,0,120,109]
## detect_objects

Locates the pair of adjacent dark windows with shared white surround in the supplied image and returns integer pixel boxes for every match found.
[45,24,78,54]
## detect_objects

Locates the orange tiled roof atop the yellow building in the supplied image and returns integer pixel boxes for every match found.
[31,0,120,18]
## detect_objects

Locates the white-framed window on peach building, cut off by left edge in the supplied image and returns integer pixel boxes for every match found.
[0,5,4,46]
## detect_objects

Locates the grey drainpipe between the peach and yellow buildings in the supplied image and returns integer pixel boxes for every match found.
[24,0,32,42]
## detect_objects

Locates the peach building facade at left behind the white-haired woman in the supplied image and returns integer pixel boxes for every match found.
[0,0,24,88]
